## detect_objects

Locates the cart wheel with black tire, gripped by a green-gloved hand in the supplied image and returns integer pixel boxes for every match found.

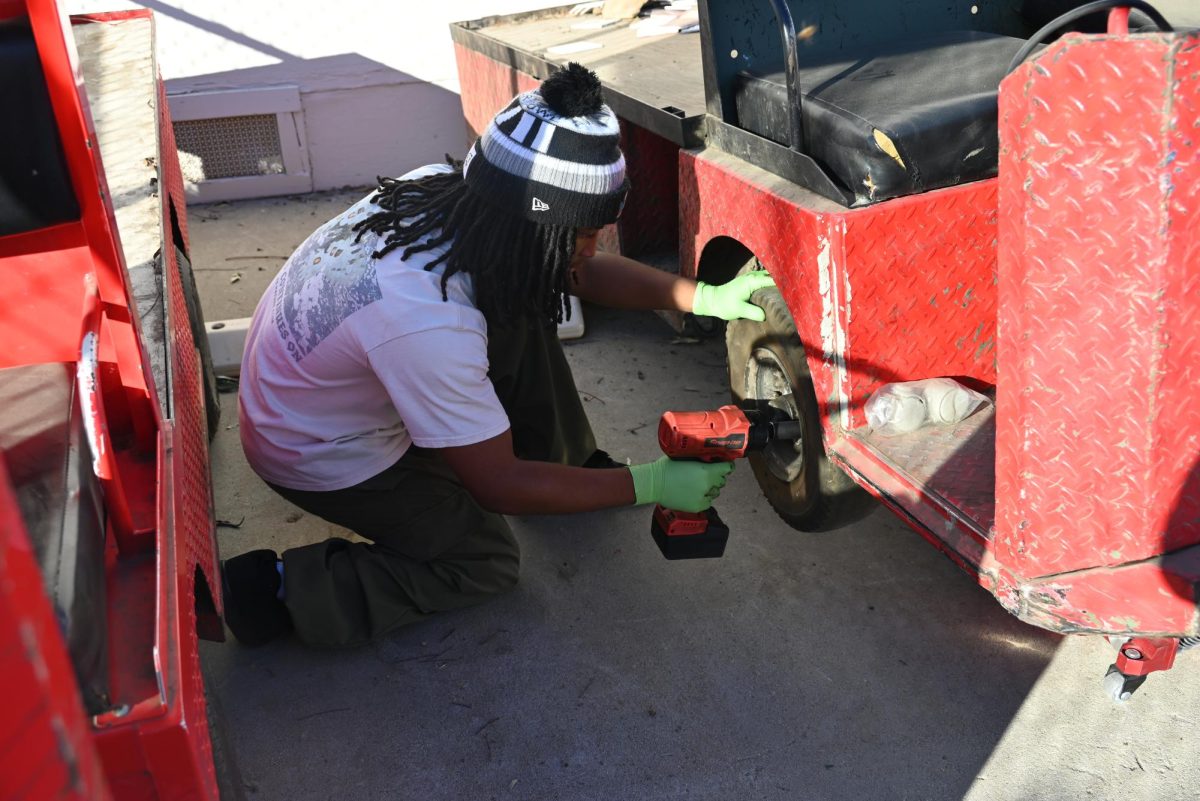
[725,259,870,531]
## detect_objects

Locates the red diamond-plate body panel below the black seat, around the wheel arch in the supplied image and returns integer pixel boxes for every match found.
[679,151,996,438]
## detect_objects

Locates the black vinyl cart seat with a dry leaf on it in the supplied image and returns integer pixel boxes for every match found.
[734,31,1024,205]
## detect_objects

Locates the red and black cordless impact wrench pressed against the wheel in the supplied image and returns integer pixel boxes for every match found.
[650,402,800,559]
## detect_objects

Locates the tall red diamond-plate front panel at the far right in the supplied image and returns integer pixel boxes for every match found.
[996,36,1200,594]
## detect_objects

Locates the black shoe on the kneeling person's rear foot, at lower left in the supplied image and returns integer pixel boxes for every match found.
[221,549,292,645]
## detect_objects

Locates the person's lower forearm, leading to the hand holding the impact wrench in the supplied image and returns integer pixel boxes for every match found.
[475,459,634,514]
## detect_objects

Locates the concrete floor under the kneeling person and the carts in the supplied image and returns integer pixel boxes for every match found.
[190,192,1200,801]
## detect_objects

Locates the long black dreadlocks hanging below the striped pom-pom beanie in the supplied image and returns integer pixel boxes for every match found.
[354,156,576,325]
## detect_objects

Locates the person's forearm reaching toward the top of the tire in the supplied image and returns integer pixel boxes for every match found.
[571,253,696,312]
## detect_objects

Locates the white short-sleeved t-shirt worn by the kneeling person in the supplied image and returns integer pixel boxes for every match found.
[238,164,509,490]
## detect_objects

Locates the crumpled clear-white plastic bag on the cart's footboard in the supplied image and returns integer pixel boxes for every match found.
[866,378,988,435]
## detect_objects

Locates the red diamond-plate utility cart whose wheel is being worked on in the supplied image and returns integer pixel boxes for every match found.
[451,0,1200,698]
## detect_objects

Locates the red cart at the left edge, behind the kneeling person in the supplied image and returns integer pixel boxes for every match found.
[0,0,223,800]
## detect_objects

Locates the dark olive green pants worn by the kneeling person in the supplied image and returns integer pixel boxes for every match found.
[271,316,596,646]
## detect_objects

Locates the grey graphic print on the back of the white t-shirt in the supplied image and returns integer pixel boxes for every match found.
[272,197,383,361]
